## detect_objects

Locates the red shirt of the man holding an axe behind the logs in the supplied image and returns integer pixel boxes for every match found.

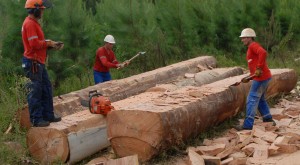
[94,46,119,72]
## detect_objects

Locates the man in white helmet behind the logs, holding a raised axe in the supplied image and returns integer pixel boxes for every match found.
[93,35,129,84]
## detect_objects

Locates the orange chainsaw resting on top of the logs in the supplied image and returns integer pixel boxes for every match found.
[89,90,115,116]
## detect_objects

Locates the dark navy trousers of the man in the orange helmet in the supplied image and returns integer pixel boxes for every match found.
[22,57,54,124]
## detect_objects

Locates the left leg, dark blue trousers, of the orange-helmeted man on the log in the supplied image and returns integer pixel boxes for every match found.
[22,58,43,125]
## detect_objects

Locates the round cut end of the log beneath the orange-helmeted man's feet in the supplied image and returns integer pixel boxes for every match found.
[26,127,69,164]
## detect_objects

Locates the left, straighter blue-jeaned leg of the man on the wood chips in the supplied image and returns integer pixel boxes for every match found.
[243,80,263,129]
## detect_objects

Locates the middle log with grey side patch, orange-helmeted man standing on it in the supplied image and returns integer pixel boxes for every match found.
[27,67,242,163]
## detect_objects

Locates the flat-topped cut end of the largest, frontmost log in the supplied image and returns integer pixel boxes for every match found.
[107,110,164,161]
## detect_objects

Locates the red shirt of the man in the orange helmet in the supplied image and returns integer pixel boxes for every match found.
[22,16,47,64]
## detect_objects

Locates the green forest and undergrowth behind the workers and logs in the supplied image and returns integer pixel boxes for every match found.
[0,0,300,164]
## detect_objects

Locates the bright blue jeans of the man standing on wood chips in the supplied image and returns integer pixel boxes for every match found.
[243,78,272,129]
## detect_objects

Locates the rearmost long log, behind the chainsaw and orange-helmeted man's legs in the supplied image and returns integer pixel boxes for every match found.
[18,56,217,128]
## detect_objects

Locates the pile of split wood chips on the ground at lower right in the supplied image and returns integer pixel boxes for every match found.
[188,98,300,165]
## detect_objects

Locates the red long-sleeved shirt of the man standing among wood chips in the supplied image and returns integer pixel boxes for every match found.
[247,42,272,81]
